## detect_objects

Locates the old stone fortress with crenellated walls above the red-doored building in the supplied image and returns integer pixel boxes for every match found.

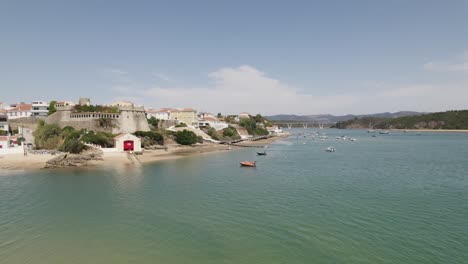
[45,98,150,134]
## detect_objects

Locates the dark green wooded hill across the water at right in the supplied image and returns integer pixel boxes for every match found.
[334,110,468,129]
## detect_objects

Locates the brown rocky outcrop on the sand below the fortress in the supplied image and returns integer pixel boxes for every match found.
[44,148,103,168]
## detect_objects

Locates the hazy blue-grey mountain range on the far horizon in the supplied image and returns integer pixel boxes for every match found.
[266,111,425,124]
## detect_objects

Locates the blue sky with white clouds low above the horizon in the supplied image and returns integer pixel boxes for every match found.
[0,0,468,114]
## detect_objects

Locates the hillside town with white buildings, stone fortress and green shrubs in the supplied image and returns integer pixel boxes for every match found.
[0,98,282,168]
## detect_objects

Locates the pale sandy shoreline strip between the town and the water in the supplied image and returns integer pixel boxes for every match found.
[0,136,285,172]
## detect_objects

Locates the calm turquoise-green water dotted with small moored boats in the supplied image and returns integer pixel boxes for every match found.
[0,130,468,264]
